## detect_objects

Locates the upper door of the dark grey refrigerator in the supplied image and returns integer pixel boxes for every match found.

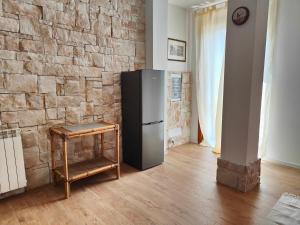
[142,70,164,123]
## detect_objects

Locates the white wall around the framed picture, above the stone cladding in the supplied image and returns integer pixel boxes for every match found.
[168,4,189,72]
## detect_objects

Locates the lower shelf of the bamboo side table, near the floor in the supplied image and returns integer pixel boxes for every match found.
[54,157,118,182]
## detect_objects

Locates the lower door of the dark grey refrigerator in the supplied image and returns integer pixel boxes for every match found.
[142,122,164,170]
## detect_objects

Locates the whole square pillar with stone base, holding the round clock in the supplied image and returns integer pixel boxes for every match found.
[217,0,269,192]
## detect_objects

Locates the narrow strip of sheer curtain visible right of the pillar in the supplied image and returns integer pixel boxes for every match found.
[258,0,279,157]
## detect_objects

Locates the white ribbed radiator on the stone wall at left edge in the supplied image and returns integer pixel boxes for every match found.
[0,129,27,194]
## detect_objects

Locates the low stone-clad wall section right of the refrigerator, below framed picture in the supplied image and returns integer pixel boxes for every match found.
[167,72,192,147]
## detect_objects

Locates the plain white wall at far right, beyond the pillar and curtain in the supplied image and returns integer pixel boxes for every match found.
[267,0,300,167]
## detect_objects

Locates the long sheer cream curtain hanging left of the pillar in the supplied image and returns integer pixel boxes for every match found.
[195,4,227,153]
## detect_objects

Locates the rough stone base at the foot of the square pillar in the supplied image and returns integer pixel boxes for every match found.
[217,158,261,192]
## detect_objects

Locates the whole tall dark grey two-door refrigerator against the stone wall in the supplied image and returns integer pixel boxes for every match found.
[121,70,164,170]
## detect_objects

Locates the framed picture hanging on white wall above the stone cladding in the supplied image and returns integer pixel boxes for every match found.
[168,38,186,62]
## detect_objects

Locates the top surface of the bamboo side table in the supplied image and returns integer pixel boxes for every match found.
[50,122,119,137]
